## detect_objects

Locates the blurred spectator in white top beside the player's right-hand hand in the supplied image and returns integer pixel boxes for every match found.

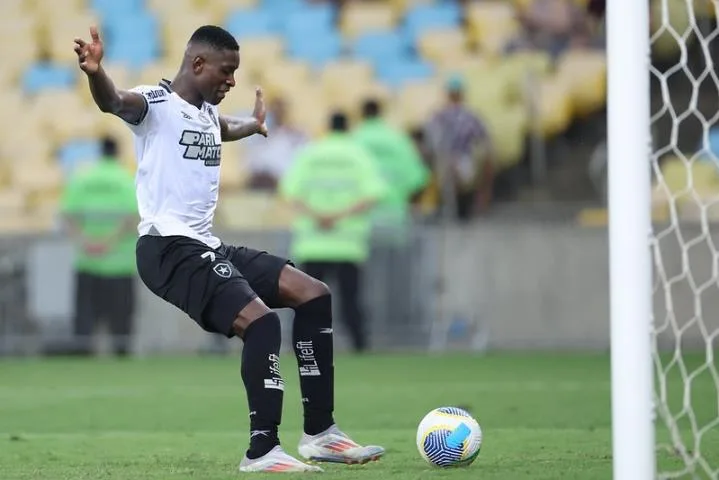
[246,98,308,191]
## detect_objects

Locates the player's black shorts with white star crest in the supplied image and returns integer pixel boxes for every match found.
[136,235,290,337]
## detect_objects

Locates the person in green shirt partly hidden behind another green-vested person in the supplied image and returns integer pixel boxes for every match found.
[353,100,429,235]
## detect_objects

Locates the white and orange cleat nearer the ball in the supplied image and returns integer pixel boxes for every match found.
[297,425,385,465]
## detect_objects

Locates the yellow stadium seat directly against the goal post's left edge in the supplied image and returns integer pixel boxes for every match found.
[557,50,607,117]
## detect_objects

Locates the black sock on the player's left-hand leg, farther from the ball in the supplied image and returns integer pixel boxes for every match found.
[241,312,285,458]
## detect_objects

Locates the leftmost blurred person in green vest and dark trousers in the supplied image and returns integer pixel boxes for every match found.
[61,138,137,356]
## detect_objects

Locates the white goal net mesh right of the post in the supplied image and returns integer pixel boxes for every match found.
[651,0,719,479]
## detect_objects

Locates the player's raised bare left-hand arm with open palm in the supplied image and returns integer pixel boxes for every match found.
[75,27,147,123]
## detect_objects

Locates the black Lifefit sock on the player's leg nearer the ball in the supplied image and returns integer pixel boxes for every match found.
[292,295,335,435]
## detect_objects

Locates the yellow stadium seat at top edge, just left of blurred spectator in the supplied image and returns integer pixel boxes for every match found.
[466,1,519,56]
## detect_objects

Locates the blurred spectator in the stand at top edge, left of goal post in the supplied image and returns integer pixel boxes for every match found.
[509,0,591,58]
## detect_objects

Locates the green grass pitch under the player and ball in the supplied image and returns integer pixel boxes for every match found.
[0,354,719,480]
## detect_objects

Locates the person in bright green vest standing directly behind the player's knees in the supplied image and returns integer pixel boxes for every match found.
[280,113,388,352]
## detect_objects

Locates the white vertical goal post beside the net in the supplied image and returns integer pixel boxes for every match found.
[606,0,656,480]
